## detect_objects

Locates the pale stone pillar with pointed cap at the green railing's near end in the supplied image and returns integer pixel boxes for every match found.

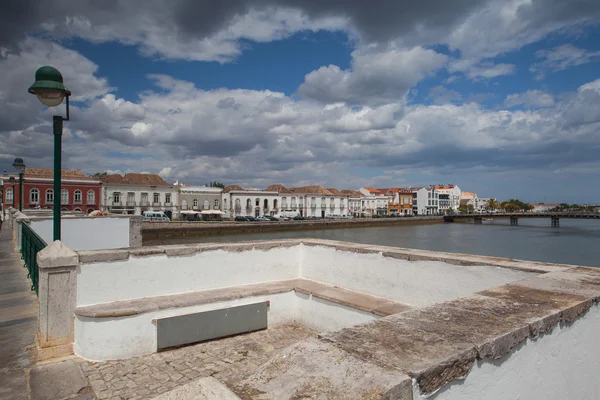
[37,240,79,360]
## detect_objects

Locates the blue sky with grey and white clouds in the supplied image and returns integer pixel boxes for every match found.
[0,0,600,203]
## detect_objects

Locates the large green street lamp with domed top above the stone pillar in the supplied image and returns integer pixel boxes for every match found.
[28,66,71,240]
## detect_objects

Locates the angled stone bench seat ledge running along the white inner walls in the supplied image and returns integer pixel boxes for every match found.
[75,279,410,318]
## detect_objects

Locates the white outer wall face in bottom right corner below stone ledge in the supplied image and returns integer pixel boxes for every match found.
[422,306,600,400]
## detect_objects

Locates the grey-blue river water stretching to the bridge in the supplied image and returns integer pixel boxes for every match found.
[150,218,600,267]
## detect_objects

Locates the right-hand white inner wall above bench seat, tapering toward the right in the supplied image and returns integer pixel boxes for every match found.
[301,246,532,307]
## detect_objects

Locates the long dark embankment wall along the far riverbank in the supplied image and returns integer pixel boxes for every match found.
[142,216,444,242]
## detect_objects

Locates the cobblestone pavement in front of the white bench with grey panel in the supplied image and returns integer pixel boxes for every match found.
[80,325,317,400]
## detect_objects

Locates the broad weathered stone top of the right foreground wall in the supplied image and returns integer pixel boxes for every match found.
[323,269,600,395]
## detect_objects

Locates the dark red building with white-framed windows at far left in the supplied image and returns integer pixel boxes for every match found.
[2,168,100,213]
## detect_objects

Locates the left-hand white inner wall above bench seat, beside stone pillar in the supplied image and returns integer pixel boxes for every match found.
[77,246,300,306]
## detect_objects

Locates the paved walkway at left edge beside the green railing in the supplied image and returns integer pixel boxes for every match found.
[0,223,37,400]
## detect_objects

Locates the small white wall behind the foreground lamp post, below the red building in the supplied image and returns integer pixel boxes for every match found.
[31,218,129,251]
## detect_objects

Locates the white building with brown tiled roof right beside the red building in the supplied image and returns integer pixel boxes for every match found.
[100,174,179,217]
